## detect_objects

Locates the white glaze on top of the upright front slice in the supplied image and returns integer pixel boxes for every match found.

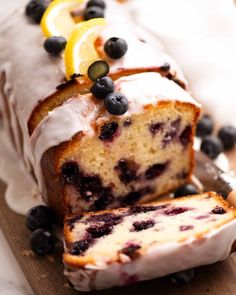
[31,72,200,197]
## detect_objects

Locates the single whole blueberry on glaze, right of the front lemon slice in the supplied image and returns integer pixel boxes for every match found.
[104,37,128,59]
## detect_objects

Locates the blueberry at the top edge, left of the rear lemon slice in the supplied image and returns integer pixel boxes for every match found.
[25,0,48,23]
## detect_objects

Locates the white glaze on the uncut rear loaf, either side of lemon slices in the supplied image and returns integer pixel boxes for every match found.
[0,1,185,166]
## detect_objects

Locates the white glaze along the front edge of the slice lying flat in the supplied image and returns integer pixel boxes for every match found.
[65,220,236,291]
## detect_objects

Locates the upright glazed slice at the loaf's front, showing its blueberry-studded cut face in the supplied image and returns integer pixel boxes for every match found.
[31,73,199,217]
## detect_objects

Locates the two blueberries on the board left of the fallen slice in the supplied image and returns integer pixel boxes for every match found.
[25,205,56,256]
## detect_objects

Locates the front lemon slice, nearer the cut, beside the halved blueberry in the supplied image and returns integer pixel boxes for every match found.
[64,18,106,79]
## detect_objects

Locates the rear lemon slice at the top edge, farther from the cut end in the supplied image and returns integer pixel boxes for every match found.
[41,0,84,39]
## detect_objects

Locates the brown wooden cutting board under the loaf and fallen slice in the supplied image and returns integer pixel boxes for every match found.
[0,151,236,295]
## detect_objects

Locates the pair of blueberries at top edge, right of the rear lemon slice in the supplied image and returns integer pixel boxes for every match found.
[83,0,106,20]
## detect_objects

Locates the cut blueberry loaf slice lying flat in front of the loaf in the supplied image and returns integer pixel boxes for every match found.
[64,193,236,291]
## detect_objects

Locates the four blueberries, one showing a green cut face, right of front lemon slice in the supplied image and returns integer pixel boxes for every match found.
[88,37,128,116]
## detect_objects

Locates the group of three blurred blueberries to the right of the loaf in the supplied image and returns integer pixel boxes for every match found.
[196,115,236,159]
